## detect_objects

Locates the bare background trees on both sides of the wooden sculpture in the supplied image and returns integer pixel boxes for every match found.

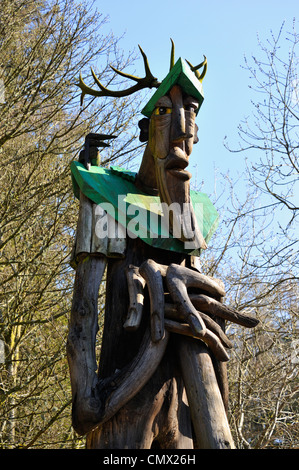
[0,0,299,448]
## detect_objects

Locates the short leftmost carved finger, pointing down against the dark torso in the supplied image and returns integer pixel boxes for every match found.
[124,264,145,331]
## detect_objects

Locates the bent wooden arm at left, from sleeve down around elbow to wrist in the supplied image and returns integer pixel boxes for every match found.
[67,256,169,434]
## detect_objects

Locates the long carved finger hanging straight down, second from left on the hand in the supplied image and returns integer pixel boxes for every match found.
[139,260,164,343]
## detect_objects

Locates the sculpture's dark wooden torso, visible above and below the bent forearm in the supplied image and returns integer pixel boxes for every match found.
[87,239,197,449]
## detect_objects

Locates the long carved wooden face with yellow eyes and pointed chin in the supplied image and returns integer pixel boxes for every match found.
[148,85,203,246]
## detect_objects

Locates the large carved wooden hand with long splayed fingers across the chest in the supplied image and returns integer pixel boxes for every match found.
[124,260,258,361]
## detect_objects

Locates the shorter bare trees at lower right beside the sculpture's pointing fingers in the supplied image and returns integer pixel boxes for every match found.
[203,173,299,449]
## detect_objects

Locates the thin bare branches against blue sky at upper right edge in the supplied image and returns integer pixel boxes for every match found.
[226,20,299,227]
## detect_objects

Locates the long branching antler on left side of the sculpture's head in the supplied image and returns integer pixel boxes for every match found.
[77,45,161,105]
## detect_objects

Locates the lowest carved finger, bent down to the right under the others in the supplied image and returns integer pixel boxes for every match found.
[165,319,229,362]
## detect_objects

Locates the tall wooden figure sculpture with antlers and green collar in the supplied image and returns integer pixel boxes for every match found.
[67,42,257,449]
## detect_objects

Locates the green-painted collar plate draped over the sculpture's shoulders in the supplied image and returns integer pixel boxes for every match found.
[71,161,219,255]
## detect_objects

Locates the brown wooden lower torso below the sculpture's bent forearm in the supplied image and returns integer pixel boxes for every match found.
[87,346,193,449]
